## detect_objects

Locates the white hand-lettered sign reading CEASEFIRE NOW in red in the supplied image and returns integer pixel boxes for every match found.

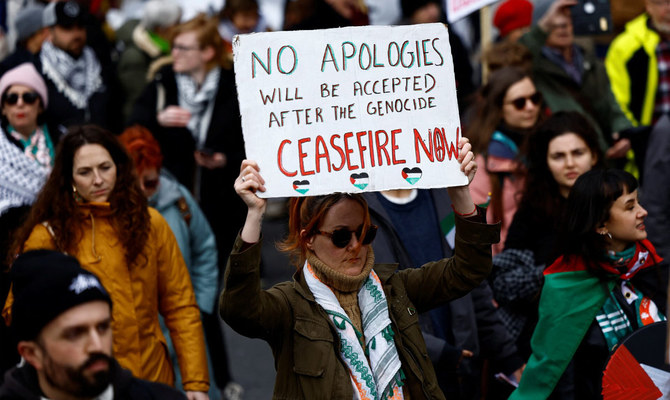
[233,24,467,197]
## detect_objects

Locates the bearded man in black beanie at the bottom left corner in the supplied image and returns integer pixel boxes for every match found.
[0,250,186,400]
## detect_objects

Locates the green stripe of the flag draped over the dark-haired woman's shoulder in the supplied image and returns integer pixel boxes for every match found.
[509,271,615,400]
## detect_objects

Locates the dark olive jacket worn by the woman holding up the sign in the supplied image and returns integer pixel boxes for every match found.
[219,214,500,400]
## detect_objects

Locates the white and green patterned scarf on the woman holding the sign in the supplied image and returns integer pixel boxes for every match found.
[303,262,404,400]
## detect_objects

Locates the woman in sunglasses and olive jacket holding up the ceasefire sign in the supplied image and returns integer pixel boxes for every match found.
[219,139,499,399]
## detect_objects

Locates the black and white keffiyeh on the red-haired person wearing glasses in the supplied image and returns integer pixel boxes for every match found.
[176,67,221,148]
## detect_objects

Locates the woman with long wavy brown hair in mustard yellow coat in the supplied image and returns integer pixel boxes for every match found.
[4,125,209,400]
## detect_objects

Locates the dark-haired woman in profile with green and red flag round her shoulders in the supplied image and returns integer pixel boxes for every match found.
[510,169,667,400]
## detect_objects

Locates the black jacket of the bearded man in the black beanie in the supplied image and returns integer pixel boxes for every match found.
[0,361,186,400]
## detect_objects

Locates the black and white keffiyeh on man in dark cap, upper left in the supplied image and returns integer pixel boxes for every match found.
[40,41,104,110]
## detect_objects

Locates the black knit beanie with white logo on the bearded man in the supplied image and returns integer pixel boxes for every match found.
[10,250,112,341]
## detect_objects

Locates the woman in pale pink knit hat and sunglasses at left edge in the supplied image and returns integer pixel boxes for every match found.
[0,63,61,373]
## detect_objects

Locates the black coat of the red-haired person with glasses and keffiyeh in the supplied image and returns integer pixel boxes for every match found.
[128,65,246,265]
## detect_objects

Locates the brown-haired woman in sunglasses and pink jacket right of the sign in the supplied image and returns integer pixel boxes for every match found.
[465,67,542,255]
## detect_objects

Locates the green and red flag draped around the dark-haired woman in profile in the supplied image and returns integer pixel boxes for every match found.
[509,240,662,400]
